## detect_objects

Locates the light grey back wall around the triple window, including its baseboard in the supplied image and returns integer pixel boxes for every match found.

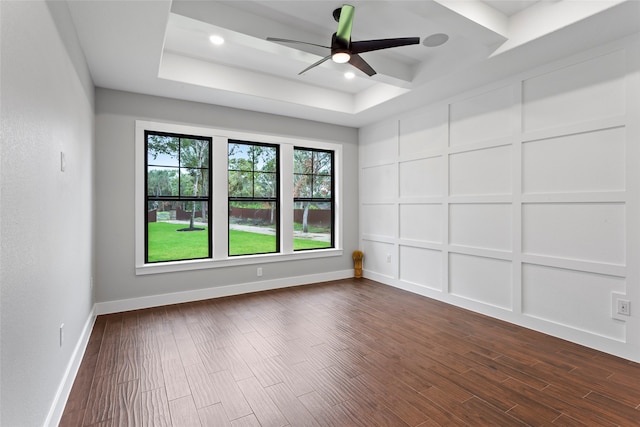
[95,89,358,312]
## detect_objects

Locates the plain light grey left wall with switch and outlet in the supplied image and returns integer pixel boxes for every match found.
[0,1,94,426]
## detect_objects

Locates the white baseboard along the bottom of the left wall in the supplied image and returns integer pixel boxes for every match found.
[44,306,96,427]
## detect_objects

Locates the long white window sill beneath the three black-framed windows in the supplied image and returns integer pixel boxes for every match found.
[136,248,343,276]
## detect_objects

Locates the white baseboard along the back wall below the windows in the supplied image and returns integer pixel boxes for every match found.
[95,270,353,315]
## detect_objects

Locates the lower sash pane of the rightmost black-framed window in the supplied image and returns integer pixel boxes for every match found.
[293,202,332,250]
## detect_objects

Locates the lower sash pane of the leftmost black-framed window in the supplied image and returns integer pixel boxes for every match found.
[147,201,211,262]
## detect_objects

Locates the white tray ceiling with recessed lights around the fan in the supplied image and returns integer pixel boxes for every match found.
[67,0,640,127]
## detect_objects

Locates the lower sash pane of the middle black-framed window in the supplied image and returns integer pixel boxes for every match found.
[229,202,278,256]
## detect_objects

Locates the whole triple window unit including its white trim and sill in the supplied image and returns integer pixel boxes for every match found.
[135,120,343,274]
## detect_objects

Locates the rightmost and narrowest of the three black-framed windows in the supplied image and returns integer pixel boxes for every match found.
[293,147,334,251]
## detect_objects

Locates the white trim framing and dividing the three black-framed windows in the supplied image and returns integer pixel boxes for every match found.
[135,120,343,275]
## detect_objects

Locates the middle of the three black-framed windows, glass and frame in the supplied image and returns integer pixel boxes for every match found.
[228,141,280,256]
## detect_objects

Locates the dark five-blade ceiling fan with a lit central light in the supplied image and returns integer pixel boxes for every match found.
[267,4,420,76]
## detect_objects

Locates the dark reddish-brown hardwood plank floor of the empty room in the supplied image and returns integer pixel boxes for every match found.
[60,279,640,427]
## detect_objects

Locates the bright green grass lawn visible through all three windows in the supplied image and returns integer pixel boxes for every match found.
[148,222,330,262]
